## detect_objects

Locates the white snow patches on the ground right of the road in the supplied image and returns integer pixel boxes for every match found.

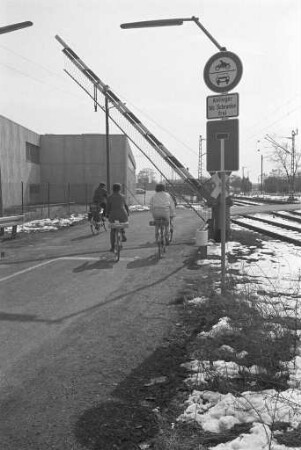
[178,226,301,450]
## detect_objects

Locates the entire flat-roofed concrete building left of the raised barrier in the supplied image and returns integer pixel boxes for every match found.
[0,116,136,215]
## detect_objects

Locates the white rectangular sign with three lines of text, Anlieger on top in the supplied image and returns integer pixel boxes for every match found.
[207,94,238,119]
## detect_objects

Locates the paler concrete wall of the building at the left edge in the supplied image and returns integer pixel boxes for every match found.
[0,116,40,211]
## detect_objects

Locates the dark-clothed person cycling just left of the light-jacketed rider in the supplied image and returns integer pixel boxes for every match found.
[107,183,129,252]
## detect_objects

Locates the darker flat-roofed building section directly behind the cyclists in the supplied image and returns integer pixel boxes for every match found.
[41,134,136,203]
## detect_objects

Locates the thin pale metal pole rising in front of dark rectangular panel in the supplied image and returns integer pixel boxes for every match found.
[221,139,226,294]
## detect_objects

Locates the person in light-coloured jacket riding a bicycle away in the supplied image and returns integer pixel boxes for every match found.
[150,183,176,245]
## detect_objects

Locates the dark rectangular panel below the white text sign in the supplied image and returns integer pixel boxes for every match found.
[206,119,239,172]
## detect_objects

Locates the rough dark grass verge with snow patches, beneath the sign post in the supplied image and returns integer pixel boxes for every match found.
[148,231,301,450]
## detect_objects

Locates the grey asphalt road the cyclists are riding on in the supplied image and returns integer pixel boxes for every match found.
[0,209,199,450]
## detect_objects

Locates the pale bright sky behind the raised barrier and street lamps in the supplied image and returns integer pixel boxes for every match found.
[0,0,301,182]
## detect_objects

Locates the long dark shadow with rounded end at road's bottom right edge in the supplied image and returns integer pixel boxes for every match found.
[74,324,191,450]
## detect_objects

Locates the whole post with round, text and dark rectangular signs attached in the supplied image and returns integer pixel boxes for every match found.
[204,51,242,294]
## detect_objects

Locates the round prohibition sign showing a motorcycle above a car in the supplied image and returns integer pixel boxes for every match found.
[204,52,242,93]
